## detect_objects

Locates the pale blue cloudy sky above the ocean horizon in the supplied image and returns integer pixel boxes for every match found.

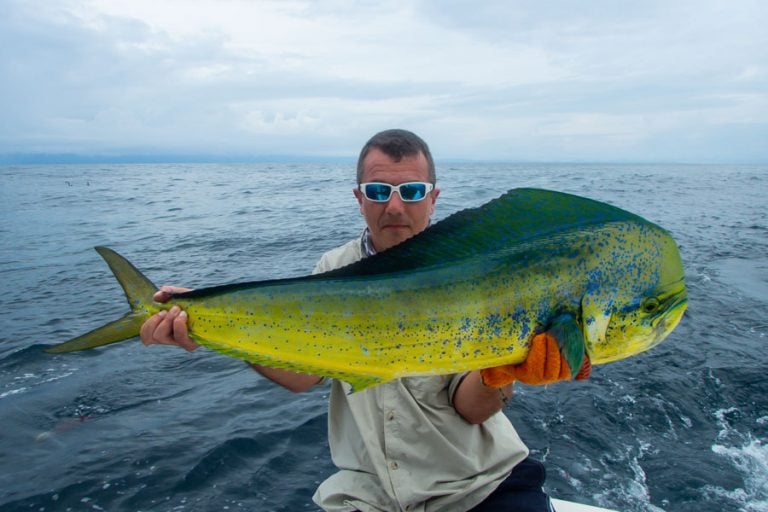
[0,0,768,163]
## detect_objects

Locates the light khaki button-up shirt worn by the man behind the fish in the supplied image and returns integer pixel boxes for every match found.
[313,239,528,512]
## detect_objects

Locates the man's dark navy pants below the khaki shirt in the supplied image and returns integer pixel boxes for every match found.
[470,457,554,512]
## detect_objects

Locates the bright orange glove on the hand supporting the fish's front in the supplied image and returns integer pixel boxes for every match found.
[480,332,592,388]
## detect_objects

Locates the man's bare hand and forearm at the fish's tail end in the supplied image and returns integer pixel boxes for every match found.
[140,286,322,393]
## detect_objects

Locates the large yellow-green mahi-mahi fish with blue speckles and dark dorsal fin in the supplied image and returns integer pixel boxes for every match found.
[48,189,688,391]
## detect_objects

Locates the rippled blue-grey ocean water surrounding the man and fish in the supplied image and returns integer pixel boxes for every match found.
[0,163,768,512]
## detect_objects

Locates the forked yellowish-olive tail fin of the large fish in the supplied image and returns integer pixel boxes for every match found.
[46,247,157,354]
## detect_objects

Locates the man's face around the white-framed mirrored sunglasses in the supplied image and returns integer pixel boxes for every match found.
[354,148,440,252]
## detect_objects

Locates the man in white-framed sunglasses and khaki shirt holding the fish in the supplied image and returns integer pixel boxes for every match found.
[141,130,584,512]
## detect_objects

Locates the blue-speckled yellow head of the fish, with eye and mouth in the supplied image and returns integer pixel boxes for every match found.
[582,228,688,364]
